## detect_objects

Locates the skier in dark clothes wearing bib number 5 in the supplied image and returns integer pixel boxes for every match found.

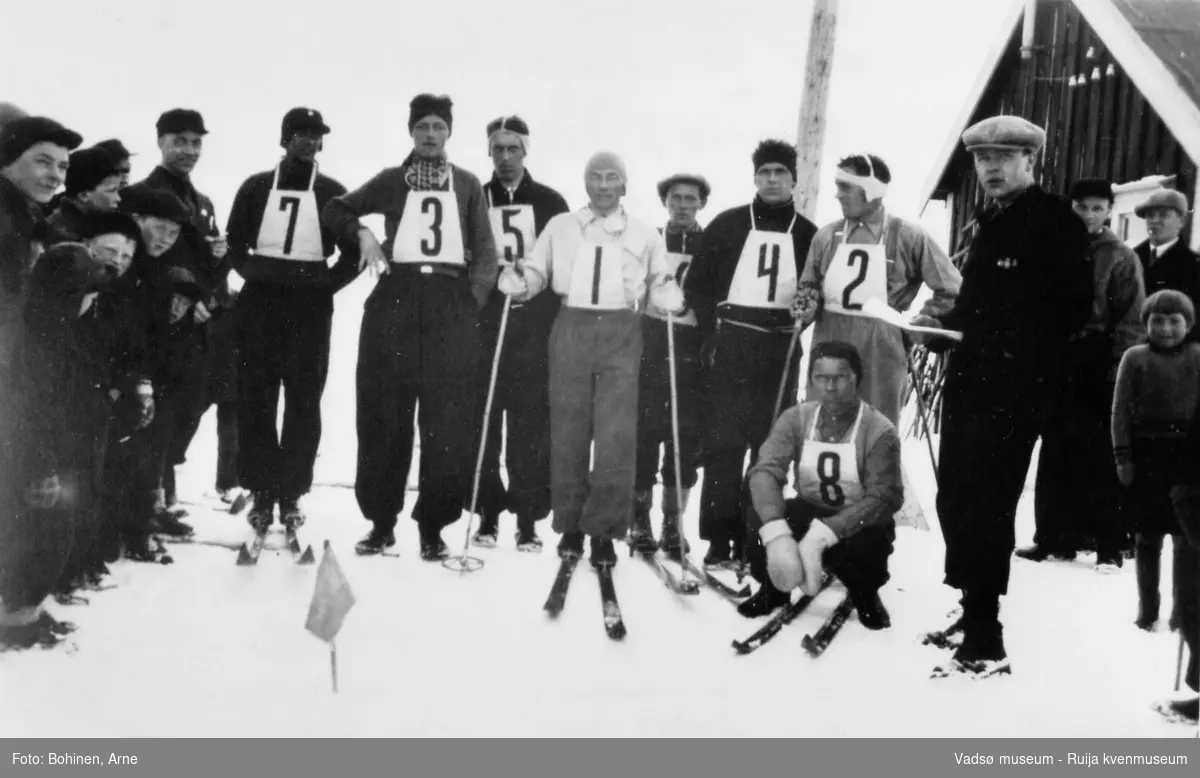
[473,116,570,551]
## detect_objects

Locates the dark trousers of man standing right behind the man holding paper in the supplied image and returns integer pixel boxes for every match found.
[1033,337,1128,559]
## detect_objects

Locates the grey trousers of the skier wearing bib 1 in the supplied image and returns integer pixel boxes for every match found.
[550,307,642,539]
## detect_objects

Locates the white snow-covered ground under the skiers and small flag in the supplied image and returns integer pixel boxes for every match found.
[0,274,1195,737]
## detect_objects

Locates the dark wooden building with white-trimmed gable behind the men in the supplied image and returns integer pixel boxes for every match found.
[920,0,1200,252]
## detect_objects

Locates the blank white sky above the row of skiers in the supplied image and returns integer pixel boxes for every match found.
[0,0,1013,239]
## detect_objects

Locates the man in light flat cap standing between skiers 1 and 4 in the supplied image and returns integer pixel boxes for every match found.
[629,173,712,558]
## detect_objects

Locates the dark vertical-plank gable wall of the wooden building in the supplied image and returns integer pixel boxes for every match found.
[938,0,1196,252]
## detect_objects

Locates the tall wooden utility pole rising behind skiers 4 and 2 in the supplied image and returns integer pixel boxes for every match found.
[794,0,838,221]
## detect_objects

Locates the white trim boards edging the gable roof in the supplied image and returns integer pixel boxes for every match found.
[920,0,1200,210]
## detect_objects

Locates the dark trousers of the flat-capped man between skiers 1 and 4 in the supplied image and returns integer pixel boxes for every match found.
[634,316,703,491]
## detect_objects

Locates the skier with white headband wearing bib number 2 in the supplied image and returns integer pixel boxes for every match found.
[797,154,962,426]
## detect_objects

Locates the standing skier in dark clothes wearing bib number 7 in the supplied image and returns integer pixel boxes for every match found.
[227,108,358,531]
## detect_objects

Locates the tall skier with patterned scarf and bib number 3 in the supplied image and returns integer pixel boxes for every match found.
[322,95,496,562]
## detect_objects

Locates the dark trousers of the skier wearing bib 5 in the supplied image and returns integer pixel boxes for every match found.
[467,292,558,523]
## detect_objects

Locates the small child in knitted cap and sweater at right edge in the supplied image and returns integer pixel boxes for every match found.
[1112,289,1200,630]
